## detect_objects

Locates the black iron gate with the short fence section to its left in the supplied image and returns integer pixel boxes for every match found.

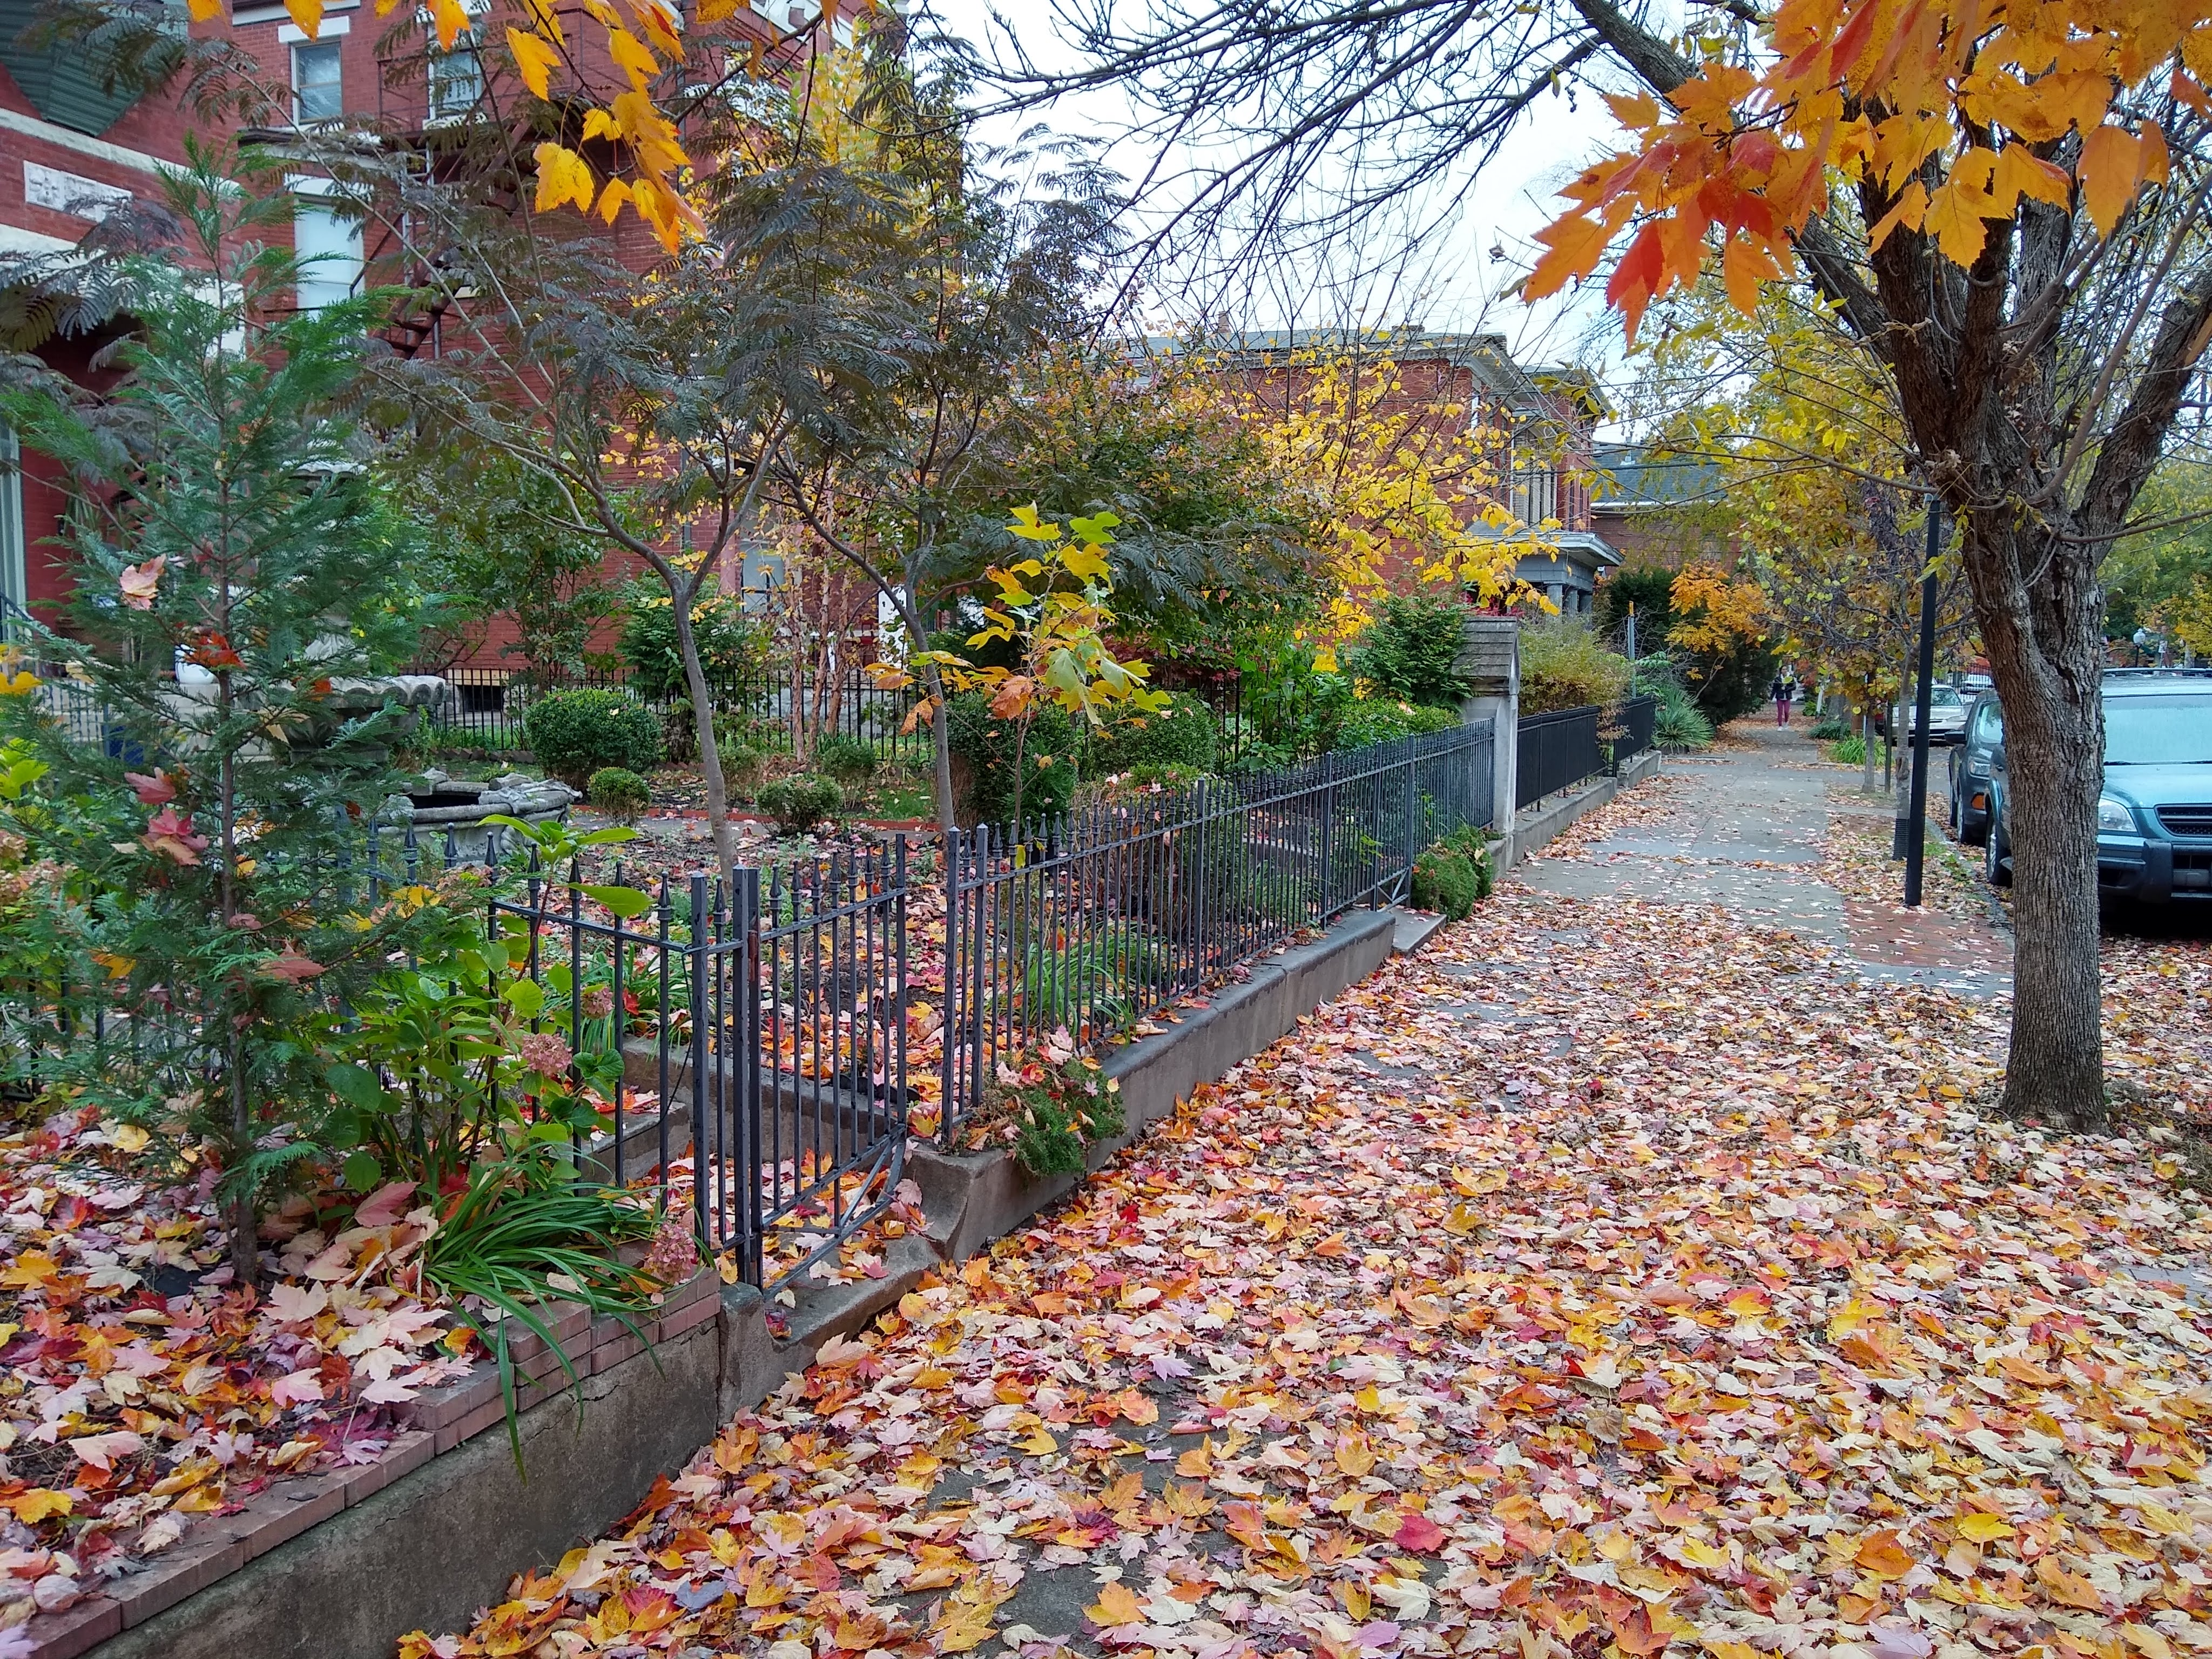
[491,838,912,1285]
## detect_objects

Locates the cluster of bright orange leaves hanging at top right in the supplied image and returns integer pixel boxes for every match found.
[1526,0,2212,334]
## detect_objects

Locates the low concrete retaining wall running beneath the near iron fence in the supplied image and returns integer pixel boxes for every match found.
[69,912,1400,1659]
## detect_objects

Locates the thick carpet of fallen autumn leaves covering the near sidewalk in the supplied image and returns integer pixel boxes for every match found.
[416,787,2212,1659]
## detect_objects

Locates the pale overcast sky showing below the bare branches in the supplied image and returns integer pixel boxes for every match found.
[915,0,1619,367]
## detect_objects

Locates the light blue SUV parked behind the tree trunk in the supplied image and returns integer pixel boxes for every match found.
[1982,668,2212,905]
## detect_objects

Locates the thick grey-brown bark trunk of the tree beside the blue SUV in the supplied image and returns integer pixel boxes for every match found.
[1964,522,2106,1128]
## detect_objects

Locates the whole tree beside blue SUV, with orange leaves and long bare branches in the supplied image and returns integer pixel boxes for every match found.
[1044,0,2212,1126]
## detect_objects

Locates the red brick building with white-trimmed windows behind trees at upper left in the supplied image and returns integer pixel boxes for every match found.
[0,0,865,637]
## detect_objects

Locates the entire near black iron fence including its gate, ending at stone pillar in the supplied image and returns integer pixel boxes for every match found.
[0,641,1495,1285]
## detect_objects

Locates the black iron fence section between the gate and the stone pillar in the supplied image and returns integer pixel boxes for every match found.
[931,721,1493,1142]
